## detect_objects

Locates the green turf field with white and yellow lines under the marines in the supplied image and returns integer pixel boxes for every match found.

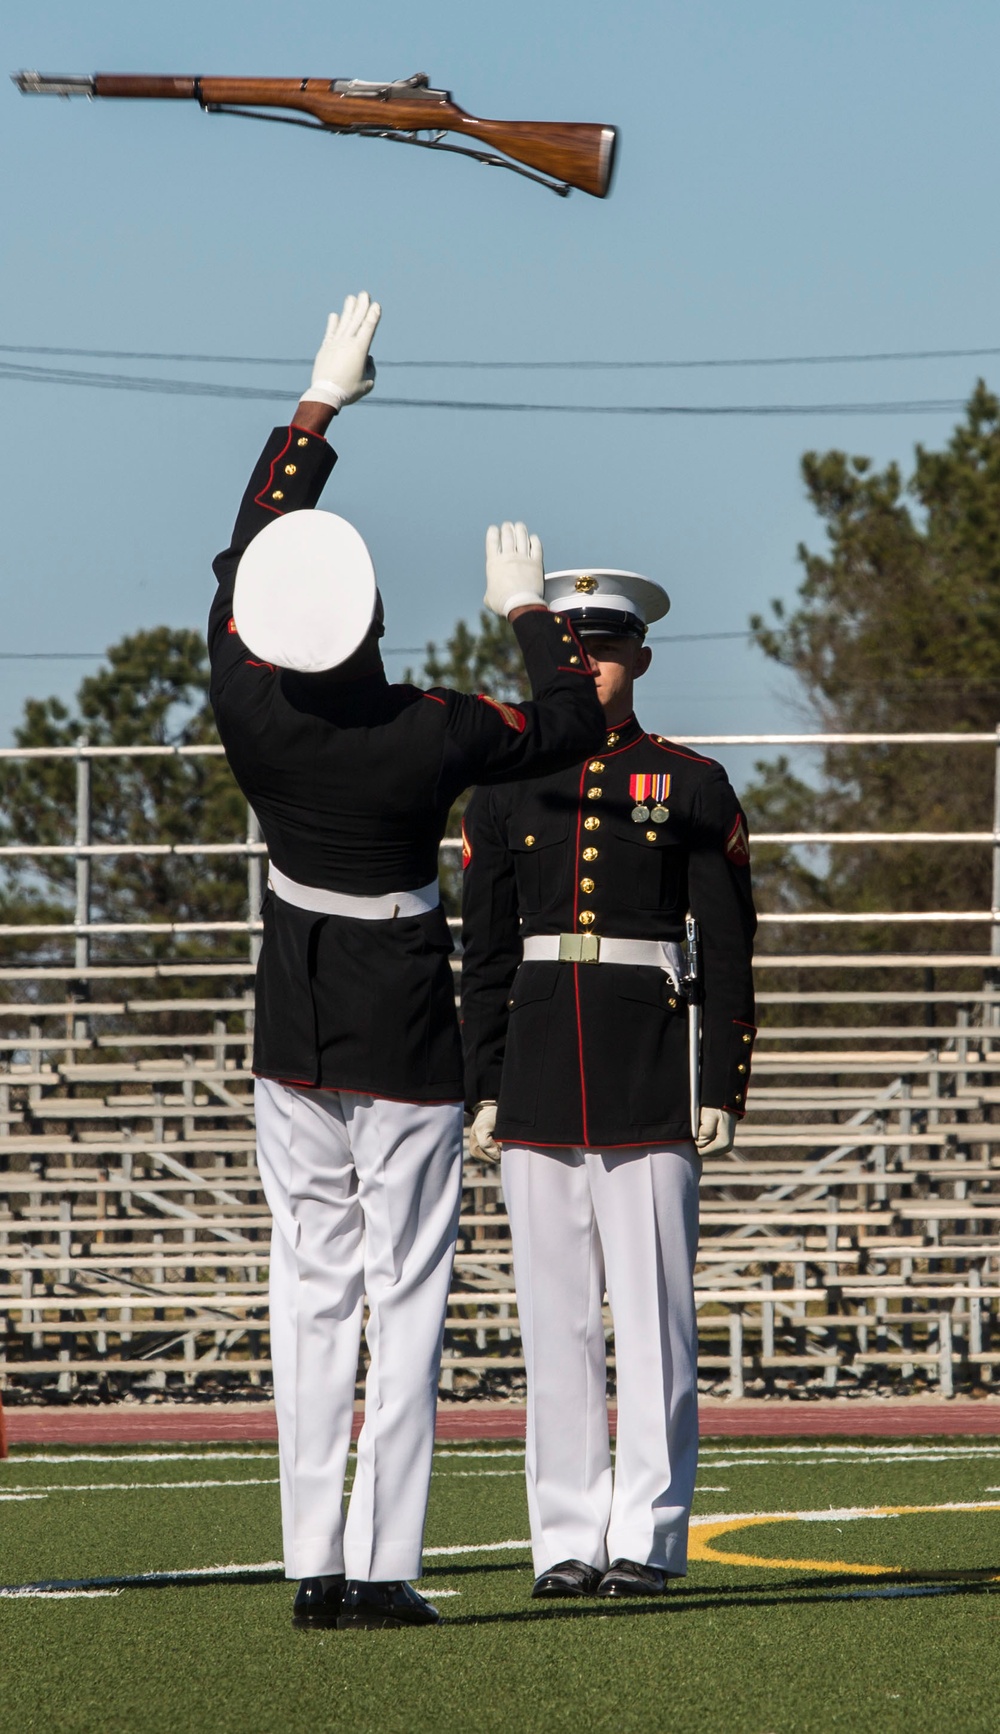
[0,1439,1000,1734]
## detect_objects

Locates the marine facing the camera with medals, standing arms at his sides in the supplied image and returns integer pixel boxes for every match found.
[461,567,756,1597]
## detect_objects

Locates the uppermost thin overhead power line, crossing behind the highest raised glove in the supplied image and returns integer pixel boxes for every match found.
[0,343,1000,373]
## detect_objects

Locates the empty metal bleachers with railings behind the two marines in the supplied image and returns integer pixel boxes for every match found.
[0,733,1000,1401]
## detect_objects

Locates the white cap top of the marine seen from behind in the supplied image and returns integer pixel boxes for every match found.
[232,512,376,675]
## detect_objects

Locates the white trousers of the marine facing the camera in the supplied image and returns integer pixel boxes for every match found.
[503,1143,700,1574]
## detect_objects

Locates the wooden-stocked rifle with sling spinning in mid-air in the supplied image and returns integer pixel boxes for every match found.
[12,73,617,199]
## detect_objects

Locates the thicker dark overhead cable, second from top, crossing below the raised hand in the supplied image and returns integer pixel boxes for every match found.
[0,361,965,418]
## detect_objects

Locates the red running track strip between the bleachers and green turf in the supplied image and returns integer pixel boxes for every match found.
[0,1398,1000,1451]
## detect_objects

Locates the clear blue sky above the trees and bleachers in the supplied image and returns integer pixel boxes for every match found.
[0,0,1000,773]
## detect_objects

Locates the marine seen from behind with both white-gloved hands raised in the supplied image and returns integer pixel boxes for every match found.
[208,295,601,1626]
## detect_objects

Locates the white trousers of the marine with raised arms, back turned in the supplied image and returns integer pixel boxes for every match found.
[255,1079,463,1583]
